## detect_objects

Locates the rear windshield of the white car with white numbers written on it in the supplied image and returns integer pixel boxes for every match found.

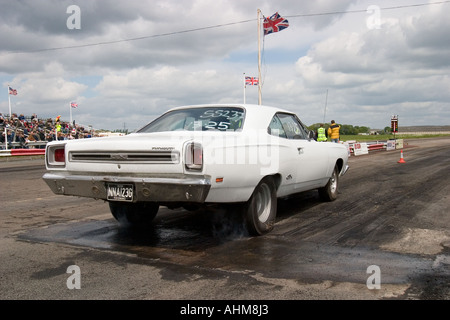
[137,107,244,132]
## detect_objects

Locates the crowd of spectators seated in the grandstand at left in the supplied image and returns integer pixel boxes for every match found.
[0,113,94,149]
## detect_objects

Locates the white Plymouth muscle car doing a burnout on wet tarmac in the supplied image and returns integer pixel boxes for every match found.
[43,104,348,235]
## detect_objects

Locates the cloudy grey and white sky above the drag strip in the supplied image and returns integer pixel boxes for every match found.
[0,0,450,130]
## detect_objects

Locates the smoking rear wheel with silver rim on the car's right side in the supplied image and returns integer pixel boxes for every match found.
[244,177,277,236]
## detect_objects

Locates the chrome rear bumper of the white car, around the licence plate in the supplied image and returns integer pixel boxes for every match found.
[42,173,211,203]
